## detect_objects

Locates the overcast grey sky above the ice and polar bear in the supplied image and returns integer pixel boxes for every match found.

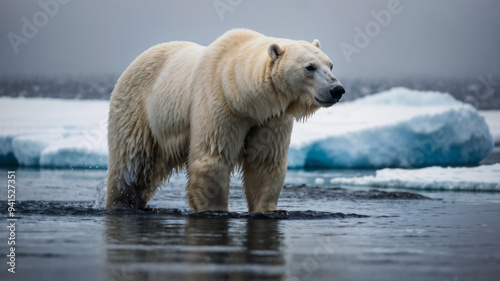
[0,0,500,78]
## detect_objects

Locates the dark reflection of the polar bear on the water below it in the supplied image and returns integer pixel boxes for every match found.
[104,214,285,281]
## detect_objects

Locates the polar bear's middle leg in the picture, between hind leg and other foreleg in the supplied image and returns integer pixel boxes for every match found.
[186,110,249,212]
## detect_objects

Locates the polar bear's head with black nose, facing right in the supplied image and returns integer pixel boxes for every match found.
[267,40,345,118]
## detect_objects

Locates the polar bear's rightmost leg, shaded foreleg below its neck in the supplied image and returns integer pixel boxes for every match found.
[242,117,293,213]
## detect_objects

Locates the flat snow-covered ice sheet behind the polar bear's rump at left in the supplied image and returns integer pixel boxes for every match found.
[0,97,109,169]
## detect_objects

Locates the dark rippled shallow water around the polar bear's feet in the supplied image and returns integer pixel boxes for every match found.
[0,169,500,281]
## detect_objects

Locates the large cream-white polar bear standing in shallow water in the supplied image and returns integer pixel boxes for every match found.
[106,29,345,212]
